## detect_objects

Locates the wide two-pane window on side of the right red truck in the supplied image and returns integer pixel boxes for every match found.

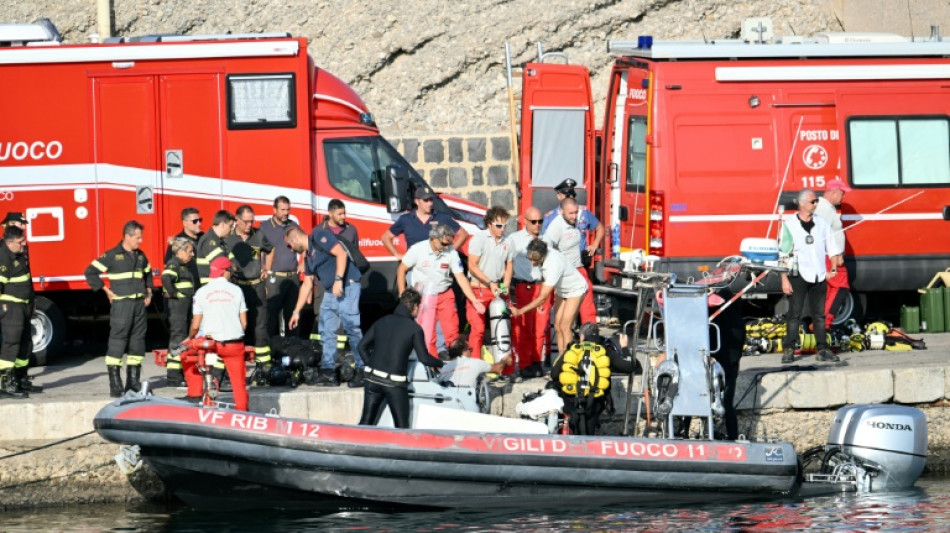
[848,117,950,186]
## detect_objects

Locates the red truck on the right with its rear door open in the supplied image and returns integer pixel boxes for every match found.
[519,19,950,321]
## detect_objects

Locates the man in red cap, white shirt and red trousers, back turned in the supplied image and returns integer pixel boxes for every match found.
[182,256,248,411]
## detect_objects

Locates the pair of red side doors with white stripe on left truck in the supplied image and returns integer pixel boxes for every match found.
[94,73,223,262]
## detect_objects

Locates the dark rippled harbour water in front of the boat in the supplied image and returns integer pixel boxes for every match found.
[0,477,950,533]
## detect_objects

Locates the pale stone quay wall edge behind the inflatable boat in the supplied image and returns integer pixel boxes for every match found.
[0,334,950,510]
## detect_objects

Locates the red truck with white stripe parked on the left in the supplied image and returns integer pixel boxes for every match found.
[0,22,484,363]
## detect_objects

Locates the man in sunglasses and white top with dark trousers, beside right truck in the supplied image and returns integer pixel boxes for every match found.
[779,189,841,365]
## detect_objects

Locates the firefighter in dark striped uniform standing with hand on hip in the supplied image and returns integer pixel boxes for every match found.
[86,220,152,398]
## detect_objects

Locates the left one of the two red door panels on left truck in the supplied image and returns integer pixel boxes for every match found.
[93,76,164,256]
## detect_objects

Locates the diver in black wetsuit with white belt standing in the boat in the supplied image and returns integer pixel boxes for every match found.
[358,289,442,429]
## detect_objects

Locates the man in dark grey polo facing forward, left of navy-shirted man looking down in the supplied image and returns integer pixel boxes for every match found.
[261,196,302,337]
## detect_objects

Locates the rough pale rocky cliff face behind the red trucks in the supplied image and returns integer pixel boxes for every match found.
[7,0,840,135]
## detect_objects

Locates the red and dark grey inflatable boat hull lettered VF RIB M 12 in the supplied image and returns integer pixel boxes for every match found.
[95,397,799,509]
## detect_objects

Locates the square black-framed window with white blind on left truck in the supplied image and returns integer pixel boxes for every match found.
[228,74,297,129]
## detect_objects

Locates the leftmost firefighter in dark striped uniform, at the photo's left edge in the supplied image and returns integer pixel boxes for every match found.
[0,225,34,398]
